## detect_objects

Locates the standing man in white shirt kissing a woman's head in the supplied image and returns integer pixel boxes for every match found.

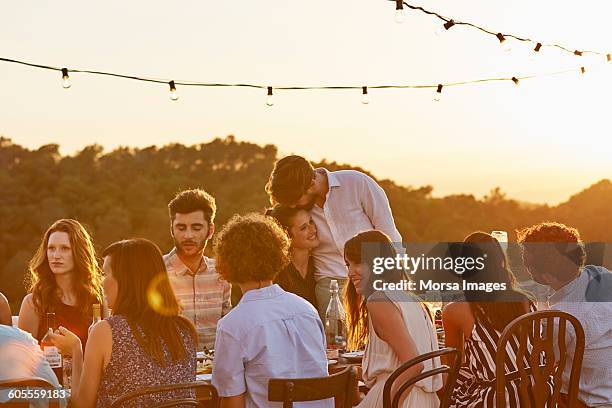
[266,156,402,320]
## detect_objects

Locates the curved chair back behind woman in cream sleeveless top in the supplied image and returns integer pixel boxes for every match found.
[383,347,462,408]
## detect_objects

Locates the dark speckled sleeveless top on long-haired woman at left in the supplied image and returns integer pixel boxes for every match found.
[96,316,196,408]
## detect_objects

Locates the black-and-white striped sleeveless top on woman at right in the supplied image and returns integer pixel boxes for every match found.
[450,302,548,408]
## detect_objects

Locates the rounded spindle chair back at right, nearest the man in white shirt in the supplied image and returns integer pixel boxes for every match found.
[495,310,584,408]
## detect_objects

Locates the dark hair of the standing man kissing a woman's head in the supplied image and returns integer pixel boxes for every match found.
[266,155,314,206]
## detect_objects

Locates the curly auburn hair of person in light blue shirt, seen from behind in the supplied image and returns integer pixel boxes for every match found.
[214,213,289,283]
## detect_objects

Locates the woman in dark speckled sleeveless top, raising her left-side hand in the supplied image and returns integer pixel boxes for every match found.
[51,239,197,408]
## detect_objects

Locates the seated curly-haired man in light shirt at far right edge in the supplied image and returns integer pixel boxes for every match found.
[518,222,612,408]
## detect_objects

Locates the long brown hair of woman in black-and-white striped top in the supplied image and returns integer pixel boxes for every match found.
[463,231,533,332]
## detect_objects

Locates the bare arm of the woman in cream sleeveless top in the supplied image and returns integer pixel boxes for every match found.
[367,300,424,395]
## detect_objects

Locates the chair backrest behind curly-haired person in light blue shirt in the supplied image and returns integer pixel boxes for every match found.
[268,366,357,408]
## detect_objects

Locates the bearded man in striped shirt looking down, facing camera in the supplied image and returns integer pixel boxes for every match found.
[164,189,231,350]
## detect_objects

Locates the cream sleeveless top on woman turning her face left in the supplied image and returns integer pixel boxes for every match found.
[363,291,442,393]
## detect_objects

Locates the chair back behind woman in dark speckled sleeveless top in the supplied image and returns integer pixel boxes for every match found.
[111,381,219,408]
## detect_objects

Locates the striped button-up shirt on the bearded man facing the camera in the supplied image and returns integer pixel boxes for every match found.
[164,248,232,350]
